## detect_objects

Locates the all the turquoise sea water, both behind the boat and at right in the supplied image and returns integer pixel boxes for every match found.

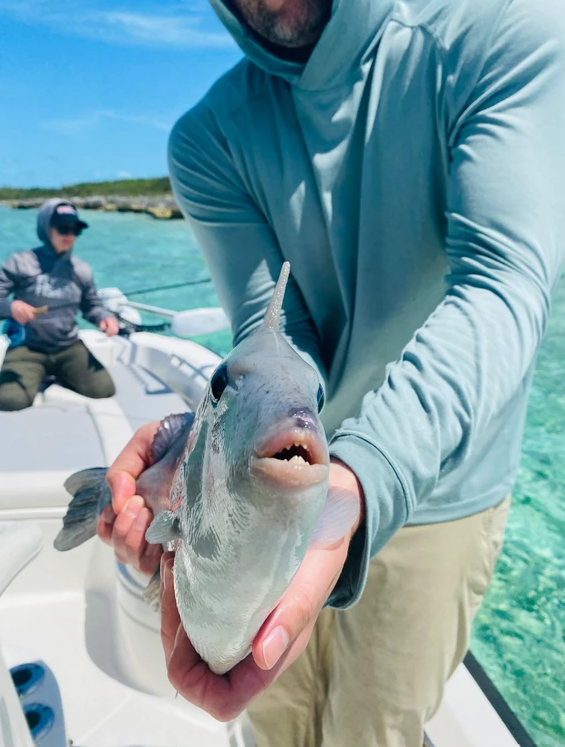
[0,206,565,747]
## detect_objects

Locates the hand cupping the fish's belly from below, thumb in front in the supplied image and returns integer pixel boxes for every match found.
[161,460,364,721]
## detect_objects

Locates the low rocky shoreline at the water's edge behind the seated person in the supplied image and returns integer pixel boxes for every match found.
[0,195,182,220]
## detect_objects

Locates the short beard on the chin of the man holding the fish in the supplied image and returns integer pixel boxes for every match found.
[234,0,332,48]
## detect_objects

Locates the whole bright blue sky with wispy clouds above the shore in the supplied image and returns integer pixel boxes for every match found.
[0,0,241,187]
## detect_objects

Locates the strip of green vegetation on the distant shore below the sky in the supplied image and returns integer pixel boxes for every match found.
[0,176,171,200]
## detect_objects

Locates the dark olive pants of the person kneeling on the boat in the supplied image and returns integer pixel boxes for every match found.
[0,340,116,410]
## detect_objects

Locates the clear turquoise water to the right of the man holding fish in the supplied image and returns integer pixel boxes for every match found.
[471,268,565,747]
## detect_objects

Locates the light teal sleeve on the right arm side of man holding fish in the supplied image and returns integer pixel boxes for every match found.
[330,0,565,607]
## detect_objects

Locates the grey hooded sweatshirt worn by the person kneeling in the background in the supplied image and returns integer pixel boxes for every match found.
[0,198,112,353]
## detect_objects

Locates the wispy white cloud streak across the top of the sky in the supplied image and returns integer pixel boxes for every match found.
[0,0,234,49]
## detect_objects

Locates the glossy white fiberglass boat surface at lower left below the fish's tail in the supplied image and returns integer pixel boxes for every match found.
[0,522,229,747]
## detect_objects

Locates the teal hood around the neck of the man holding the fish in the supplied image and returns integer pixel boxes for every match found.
[205,0,394,91]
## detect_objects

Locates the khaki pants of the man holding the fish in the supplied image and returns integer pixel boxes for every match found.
[248,496,510,747]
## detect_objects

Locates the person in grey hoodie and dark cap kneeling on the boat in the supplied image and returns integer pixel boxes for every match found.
[0,199,118,410]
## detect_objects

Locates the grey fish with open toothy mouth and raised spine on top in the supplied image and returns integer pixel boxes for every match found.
[54,262,358,675]
